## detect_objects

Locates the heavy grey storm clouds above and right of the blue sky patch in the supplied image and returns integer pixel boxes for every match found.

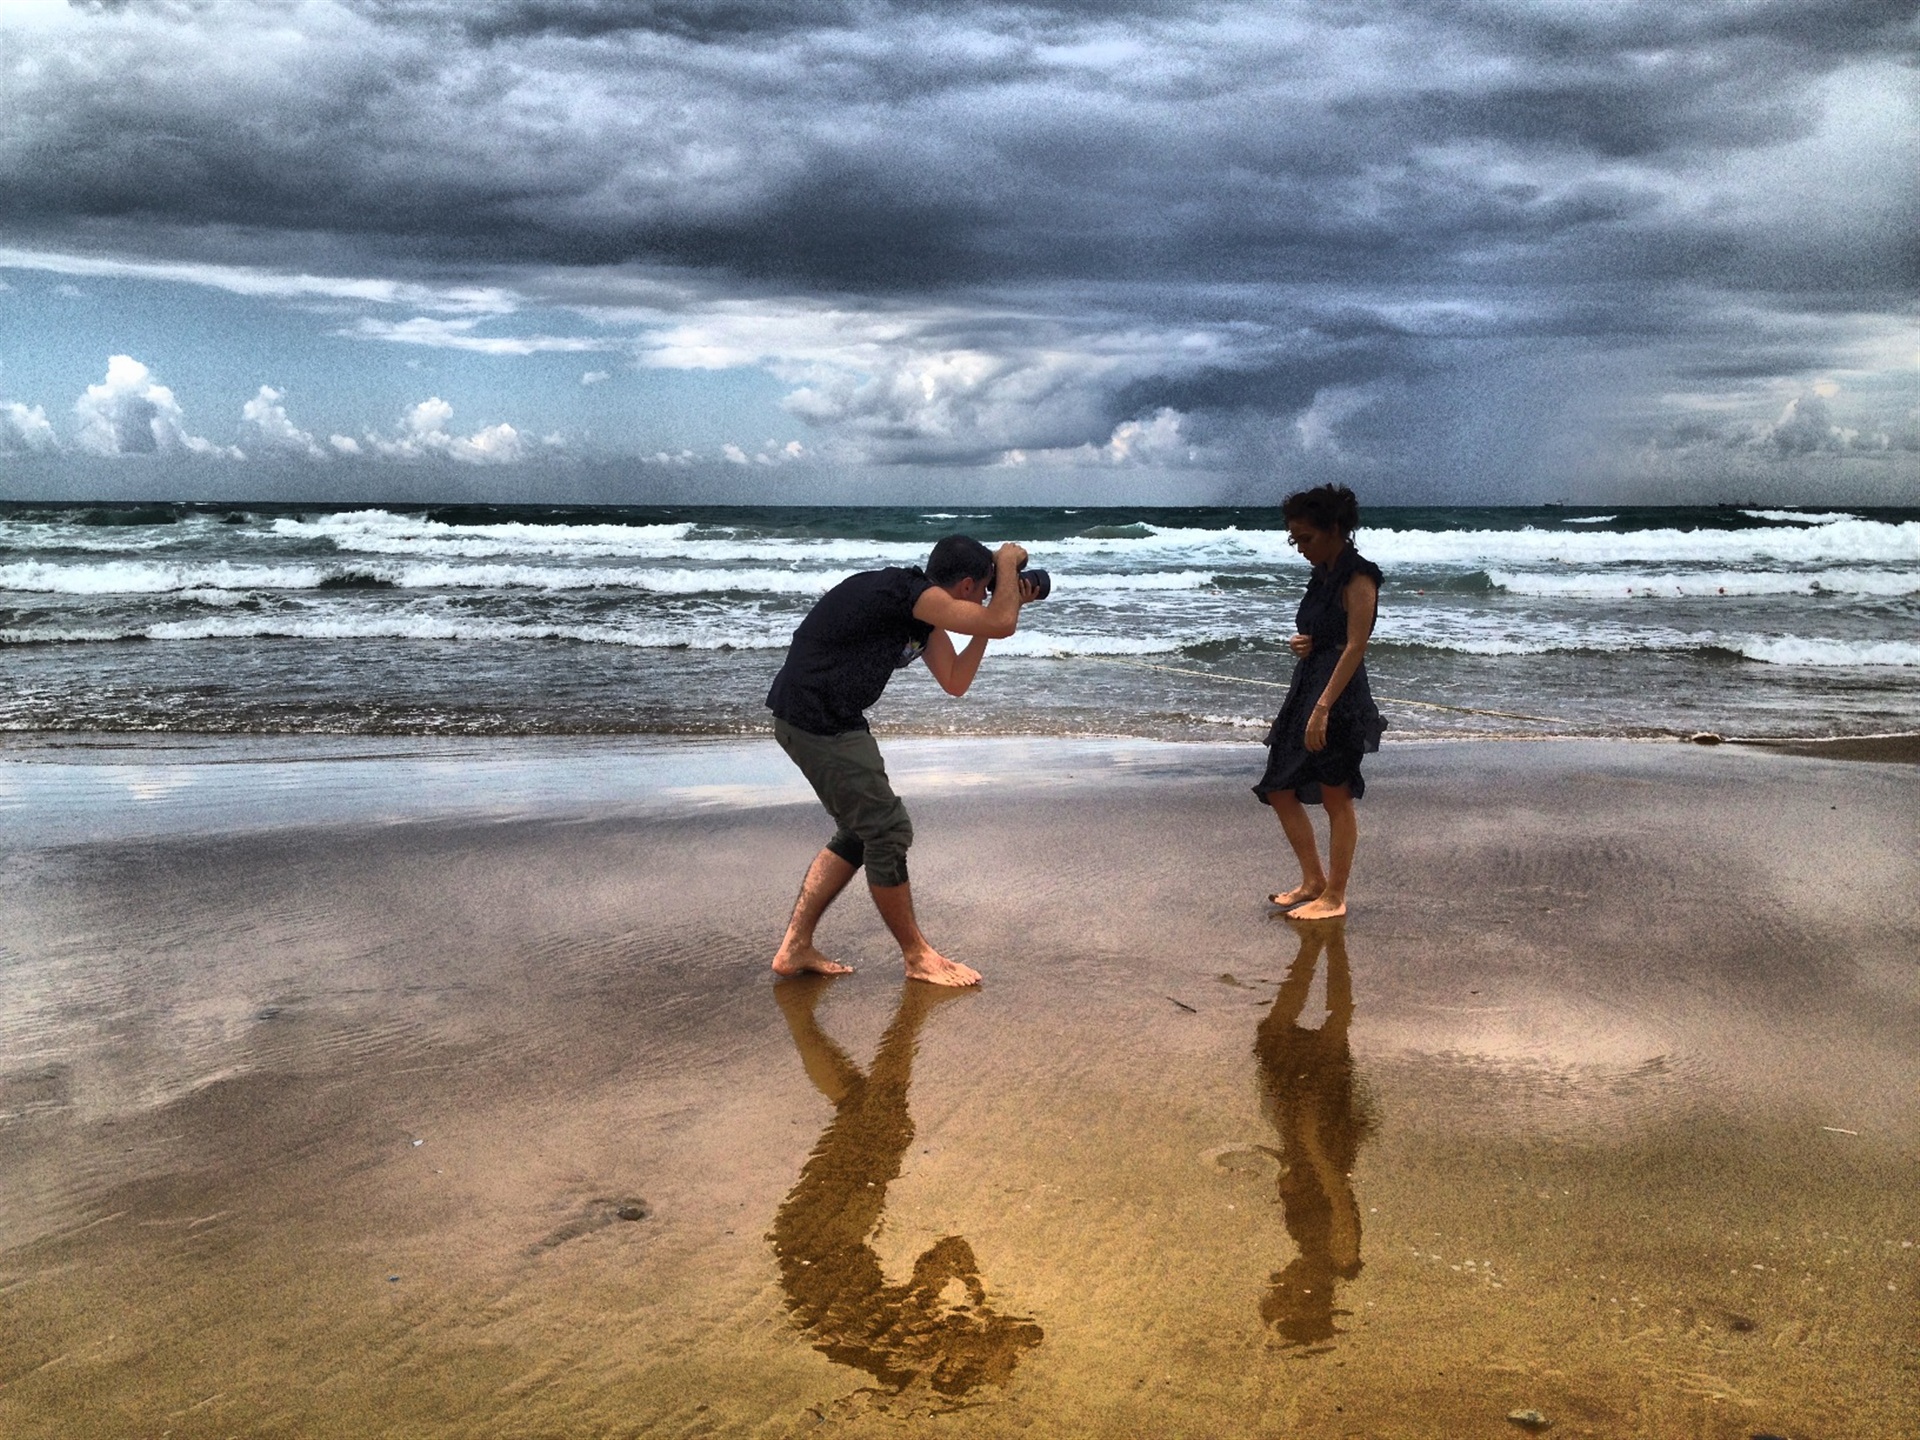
[0,0,1920,503]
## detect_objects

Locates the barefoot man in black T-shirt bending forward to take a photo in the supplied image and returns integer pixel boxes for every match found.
[766,536,1044,985]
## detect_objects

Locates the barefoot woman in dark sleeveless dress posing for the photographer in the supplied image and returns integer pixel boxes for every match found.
[1254,486,1386,920]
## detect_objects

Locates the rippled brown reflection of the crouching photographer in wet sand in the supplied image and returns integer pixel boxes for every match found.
[770,977,1043,1396]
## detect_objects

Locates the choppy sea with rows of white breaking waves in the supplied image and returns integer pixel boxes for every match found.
[0,503,1920,743]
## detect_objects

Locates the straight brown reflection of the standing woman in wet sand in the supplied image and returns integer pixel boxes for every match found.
[1254,920,1373,1346]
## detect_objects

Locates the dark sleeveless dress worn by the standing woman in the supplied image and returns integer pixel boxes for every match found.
[1254,545,1386,804]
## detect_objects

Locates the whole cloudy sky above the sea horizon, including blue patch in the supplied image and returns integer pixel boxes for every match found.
[0,0,1920,505]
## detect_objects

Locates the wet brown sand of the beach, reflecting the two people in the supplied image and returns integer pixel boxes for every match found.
[0,741,1920,1440]
